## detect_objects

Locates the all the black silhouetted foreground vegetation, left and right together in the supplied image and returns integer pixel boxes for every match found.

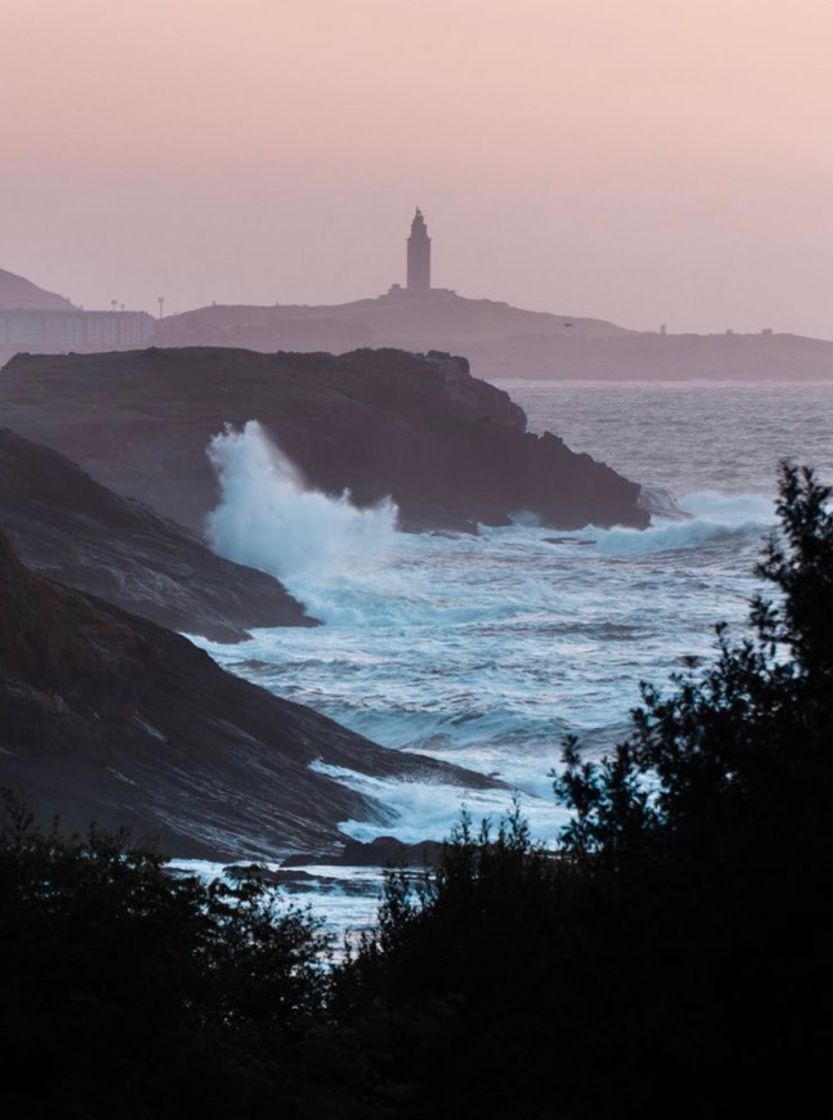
[0,466,833,1120]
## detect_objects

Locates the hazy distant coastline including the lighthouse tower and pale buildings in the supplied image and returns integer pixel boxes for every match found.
[0,207,833,381]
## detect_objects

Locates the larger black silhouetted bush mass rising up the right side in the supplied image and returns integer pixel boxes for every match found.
[335,464,833,1118]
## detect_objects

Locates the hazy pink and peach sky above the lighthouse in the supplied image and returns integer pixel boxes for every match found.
[0,0,833,337]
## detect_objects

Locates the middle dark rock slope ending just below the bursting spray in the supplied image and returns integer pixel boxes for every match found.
[0,428,312,642]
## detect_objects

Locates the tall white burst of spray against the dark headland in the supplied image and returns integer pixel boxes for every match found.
[207,420,396,584]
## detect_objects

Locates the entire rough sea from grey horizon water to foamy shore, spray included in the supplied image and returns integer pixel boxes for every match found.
[179,381,833,930]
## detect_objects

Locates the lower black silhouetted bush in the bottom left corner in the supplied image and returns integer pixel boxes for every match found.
[0,799,338,1118]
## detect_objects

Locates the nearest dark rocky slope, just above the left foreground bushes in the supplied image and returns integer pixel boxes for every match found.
[0,536,490,859]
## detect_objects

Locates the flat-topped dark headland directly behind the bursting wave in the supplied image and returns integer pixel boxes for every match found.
[0,347,648,531]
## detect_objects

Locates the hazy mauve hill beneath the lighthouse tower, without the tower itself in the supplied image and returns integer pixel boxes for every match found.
[152,289,833,381]
